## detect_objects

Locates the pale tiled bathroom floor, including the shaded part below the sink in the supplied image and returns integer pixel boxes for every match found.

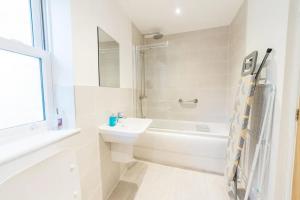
[110,162,227,200]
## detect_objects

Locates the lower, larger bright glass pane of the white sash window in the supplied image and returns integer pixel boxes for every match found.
[0,50,45,129]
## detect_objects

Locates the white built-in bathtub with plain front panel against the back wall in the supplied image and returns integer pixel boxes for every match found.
[134,119,229,174]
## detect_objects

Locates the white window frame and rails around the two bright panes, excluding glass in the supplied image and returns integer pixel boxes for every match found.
[0,0,54,136]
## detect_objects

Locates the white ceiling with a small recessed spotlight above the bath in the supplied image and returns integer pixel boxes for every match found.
[116,0,243,34]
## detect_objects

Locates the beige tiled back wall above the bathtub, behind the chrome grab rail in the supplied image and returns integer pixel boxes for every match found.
[145,27,230,122]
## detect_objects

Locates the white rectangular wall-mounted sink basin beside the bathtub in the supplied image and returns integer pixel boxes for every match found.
[99,118,152,144]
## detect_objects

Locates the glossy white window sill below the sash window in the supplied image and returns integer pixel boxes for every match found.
[0,129,80,166]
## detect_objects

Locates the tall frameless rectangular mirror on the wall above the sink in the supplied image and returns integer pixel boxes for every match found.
[97,27,120,88]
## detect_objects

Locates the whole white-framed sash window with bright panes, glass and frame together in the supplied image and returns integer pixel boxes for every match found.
[0,0,51,129]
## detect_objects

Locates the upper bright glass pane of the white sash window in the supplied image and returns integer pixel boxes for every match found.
[0,0,33,45]
